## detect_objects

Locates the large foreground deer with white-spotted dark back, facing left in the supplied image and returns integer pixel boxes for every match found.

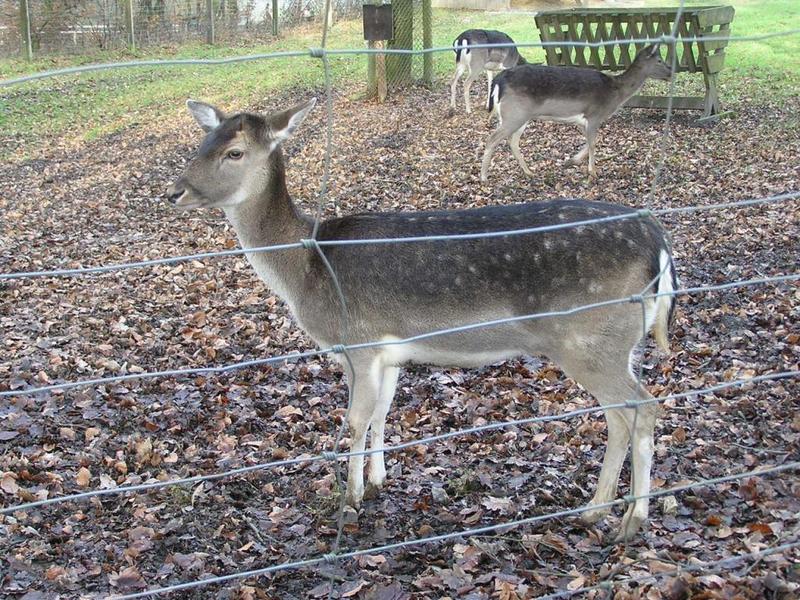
[167,99,675,539]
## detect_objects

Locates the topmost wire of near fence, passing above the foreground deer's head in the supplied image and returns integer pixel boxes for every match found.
[0,28,800,87]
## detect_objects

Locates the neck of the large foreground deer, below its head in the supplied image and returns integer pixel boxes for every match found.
[224,149,312,308]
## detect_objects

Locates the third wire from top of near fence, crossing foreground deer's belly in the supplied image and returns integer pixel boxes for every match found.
[0,273,800,398]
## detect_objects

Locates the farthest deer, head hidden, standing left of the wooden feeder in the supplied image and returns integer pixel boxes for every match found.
[450,29,526,113]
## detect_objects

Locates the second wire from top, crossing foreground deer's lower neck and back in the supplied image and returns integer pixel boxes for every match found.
[0,191,800,281]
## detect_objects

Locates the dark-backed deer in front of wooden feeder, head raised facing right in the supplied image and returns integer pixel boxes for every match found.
[481,44,672,181]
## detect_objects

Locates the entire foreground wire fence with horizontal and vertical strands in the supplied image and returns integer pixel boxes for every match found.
[0,2,800,599]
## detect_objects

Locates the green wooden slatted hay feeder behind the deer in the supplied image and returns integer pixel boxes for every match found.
[535,6,734,117]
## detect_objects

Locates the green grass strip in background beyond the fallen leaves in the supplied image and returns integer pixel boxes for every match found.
[0,0,800,158]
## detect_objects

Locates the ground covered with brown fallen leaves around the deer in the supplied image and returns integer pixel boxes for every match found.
[0,81,800,600]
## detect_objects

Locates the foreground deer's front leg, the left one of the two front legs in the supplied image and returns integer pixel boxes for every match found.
[345,360,388,508]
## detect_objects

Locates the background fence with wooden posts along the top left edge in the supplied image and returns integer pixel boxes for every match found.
[0,0,362,57]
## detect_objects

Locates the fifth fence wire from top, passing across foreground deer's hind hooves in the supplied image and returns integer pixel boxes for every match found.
[100,461,800,600]
